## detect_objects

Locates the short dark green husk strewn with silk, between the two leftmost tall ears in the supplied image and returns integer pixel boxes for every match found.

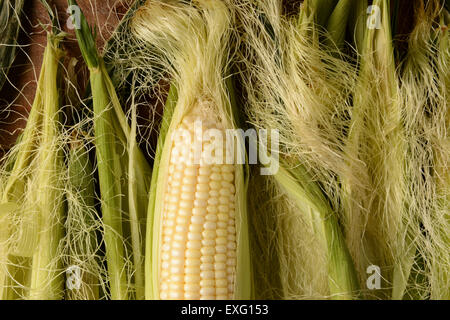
[64,135,103,300]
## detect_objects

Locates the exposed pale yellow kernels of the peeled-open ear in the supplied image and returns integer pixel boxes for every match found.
[155,112,243,300]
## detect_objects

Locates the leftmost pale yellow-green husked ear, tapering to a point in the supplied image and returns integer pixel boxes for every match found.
[1,21,63,299]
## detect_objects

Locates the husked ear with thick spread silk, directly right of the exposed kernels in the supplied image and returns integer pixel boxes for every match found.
[236,1,359,299]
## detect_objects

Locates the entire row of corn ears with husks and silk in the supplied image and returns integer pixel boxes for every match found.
[0,0,450,300]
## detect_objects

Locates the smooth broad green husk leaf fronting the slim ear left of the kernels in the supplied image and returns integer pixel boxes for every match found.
[91,69,128,300]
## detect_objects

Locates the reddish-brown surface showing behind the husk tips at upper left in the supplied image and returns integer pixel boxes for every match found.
[0,0,133,151]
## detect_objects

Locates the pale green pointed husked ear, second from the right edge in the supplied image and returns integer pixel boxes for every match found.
[342,1,414,296]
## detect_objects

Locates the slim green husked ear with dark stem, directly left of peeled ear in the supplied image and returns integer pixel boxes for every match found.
[68,0,151,299]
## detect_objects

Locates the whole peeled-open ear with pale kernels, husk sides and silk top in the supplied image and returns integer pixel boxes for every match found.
[132,1,252,299]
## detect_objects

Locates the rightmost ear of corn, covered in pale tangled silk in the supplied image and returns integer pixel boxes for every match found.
[400,1,450,299]
